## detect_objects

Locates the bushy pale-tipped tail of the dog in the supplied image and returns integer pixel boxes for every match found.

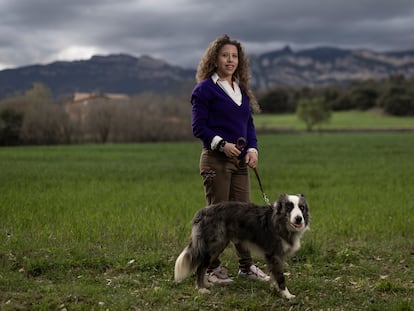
[174,226,201,282]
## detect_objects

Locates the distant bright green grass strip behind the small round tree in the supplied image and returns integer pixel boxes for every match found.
[255,111,414,131]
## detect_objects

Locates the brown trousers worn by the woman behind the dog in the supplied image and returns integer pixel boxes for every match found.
[200,149,253,272]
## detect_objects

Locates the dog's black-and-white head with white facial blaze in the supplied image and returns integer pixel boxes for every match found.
[274,194,310,232]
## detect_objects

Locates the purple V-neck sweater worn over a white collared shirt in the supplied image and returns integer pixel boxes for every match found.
[191,78,257,156]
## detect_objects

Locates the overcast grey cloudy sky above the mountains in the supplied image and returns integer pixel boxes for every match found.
[0,0,414,70]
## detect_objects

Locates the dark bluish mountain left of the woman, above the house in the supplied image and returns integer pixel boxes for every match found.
[0,54,195,98]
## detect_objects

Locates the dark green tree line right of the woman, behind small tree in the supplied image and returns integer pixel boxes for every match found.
[260,75,414,116]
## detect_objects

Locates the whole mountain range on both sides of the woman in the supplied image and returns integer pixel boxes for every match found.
[0,46,414,98]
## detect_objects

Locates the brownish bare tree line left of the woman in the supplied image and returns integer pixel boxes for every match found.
[0,83,192,145]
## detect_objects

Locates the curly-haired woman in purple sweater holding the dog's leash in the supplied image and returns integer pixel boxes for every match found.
[191,35,270,284]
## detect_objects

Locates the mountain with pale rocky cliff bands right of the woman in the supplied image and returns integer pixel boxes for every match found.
[250,46,414,89]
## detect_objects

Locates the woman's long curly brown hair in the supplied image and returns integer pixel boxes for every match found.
[196,35,260,112]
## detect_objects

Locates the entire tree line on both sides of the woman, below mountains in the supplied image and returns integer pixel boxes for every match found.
[0,76,414,145]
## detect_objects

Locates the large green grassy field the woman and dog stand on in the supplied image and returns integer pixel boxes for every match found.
[0,132,414,310]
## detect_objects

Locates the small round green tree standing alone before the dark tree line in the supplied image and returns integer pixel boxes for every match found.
[296,97,331,132]
